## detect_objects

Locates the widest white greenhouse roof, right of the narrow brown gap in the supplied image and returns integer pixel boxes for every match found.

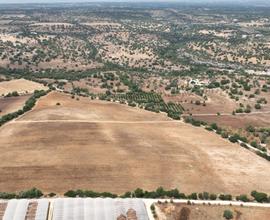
[53,198,148,220]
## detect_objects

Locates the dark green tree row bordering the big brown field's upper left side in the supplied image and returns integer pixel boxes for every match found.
[0,90,49,126]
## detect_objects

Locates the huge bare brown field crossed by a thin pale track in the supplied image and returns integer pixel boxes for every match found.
[0,92,270,194]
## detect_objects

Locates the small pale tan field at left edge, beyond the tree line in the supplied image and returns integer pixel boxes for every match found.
[0,79,47,95]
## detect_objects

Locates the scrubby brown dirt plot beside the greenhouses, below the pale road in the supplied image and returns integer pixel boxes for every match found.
[157,203,270,220]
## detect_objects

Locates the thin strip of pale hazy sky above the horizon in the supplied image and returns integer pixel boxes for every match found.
[0,0,270,4]
